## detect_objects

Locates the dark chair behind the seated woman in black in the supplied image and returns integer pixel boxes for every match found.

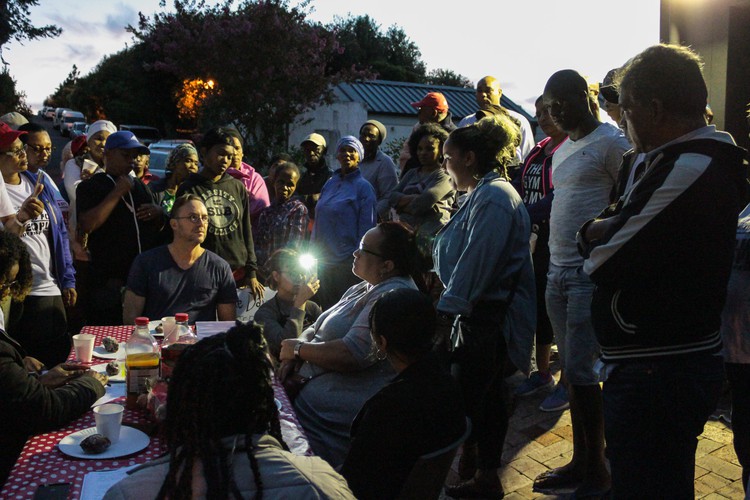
[397,418,471,500]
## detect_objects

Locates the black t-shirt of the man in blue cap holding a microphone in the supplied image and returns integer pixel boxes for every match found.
[76,173,164,284]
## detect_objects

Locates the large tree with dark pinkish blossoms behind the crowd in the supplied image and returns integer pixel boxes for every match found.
[129,0,360,160]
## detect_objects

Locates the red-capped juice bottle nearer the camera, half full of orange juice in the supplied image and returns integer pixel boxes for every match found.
[125,317,161,409]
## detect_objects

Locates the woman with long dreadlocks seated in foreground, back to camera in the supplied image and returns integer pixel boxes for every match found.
[104,323,354,499]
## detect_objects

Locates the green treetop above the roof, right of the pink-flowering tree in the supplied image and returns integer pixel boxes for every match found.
[328,15,426,83]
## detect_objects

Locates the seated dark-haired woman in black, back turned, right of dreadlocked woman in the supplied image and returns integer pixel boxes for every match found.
[341,288,466,500]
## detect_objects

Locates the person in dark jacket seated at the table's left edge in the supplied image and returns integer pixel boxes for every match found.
[0,231,107,484]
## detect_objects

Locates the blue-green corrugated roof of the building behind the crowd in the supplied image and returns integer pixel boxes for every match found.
[334,80,534,123]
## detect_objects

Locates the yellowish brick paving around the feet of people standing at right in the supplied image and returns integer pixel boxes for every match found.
[441,365,744,500]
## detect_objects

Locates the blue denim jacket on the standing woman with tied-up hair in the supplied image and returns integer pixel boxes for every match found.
[432,172,530,315]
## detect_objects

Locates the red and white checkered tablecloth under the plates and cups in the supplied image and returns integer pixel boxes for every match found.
[0,326,312,500]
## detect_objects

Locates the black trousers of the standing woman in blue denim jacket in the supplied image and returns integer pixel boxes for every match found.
[451,301,508,469]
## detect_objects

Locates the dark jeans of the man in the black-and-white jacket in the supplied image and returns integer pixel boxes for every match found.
[603,354,724,499]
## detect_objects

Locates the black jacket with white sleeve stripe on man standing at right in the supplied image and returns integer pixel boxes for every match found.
[584,126,745,362]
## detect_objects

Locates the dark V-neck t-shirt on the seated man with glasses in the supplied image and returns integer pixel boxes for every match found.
[128,245,237,323]
